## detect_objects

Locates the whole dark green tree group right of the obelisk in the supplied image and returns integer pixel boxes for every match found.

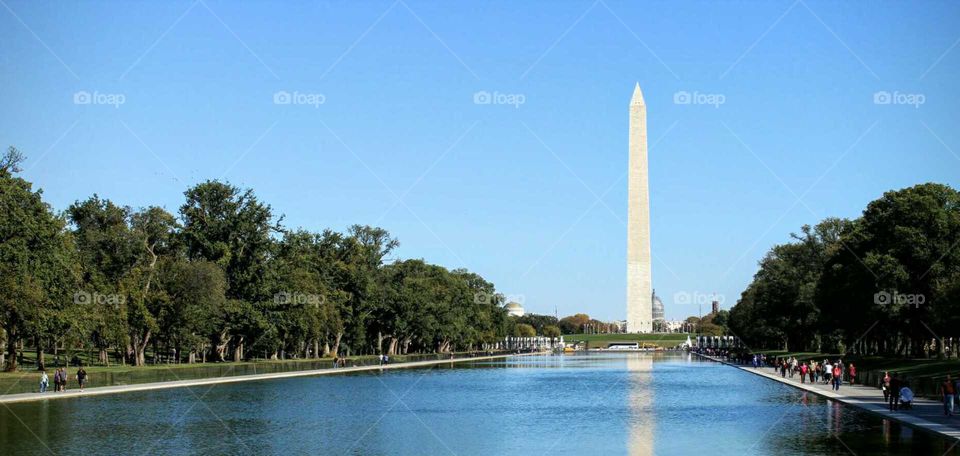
[726,183,960,356]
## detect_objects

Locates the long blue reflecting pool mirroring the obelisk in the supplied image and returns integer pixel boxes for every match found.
[0,353,960,456]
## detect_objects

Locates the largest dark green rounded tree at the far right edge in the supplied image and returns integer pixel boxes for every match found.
[817,183,960,355]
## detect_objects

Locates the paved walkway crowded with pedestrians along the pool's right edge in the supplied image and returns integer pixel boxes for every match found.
[696,353,960,439]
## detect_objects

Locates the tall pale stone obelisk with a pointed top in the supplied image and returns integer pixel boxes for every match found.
[627,83,653,333]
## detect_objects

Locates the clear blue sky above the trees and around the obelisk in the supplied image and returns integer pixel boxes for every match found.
[0,0,960,319]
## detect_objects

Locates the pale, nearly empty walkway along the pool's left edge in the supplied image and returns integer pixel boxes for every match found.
[0,353,543,404]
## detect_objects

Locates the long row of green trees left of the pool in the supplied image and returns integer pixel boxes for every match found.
[0,147,520,370]
